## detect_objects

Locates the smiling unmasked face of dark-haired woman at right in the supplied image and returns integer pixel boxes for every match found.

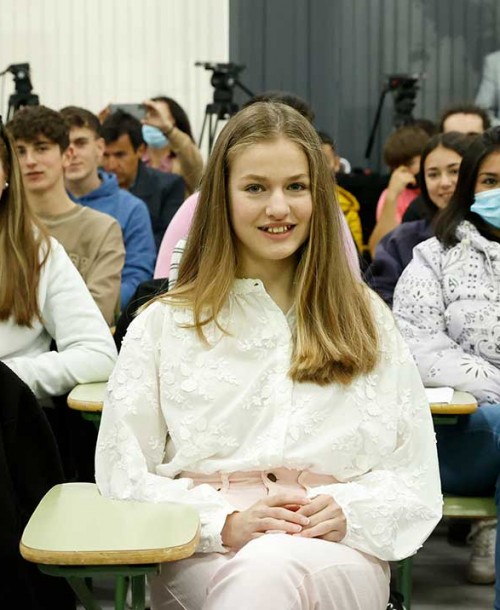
[424,146,462,209]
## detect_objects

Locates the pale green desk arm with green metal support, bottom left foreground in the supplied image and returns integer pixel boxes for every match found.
[20,483,200,610]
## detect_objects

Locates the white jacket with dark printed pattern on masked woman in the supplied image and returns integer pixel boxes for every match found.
[393,221,500,404]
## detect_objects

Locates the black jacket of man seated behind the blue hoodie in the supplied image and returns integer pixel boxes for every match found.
[129,161,185,251]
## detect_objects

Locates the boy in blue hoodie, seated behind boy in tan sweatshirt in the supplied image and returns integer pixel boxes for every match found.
[61,106,156,309]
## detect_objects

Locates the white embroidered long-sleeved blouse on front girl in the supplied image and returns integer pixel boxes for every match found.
[96,280,442,560]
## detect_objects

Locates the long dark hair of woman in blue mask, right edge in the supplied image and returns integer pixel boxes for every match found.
[435,127,500,247]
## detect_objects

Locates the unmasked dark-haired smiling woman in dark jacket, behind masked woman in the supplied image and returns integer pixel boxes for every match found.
[365,132,474,307]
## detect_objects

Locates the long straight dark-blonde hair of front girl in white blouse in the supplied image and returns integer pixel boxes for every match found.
[161,102,378,385]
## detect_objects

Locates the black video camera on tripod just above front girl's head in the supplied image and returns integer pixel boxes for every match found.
[194,61,253,152]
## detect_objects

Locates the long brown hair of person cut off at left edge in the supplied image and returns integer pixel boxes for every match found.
[0,118,50,327]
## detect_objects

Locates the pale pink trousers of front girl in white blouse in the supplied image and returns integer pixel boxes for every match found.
[151,468,390,610]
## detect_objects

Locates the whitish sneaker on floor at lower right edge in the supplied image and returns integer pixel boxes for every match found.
[467,519,497,585]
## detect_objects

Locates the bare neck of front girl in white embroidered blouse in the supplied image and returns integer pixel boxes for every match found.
[238,259,297,313]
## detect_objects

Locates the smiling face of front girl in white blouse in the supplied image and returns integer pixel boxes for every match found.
[228,138,312,277]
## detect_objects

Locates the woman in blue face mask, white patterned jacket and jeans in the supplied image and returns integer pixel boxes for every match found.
[394,127,500,588]
